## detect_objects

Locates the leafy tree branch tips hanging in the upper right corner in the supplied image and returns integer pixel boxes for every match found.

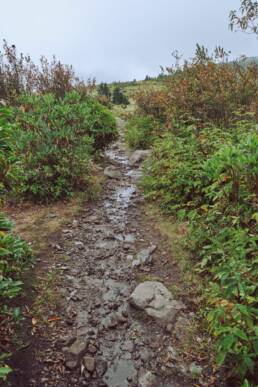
[229,0,258,35]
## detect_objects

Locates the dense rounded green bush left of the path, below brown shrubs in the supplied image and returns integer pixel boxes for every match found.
[1,92,117,201]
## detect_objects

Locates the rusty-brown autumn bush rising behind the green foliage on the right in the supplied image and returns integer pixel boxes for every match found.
[136,46,258,128]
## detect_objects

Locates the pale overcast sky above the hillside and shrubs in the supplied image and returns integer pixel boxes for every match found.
[0,0,258,81]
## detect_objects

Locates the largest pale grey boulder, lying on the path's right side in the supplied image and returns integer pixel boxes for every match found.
[129,281,184,323]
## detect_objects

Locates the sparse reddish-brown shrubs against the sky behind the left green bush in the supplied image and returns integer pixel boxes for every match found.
[0,40,95,104]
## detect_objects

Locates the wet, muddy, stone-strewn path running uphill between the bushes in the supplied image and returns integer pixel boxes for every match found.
[10,121,220,387]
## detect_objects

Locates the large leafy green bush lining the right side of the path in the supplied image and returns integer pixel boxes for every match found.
[142,122,258,384]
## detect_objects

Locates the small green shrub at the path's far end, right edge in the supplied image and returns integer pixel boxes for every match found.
[125,116,156,149]
